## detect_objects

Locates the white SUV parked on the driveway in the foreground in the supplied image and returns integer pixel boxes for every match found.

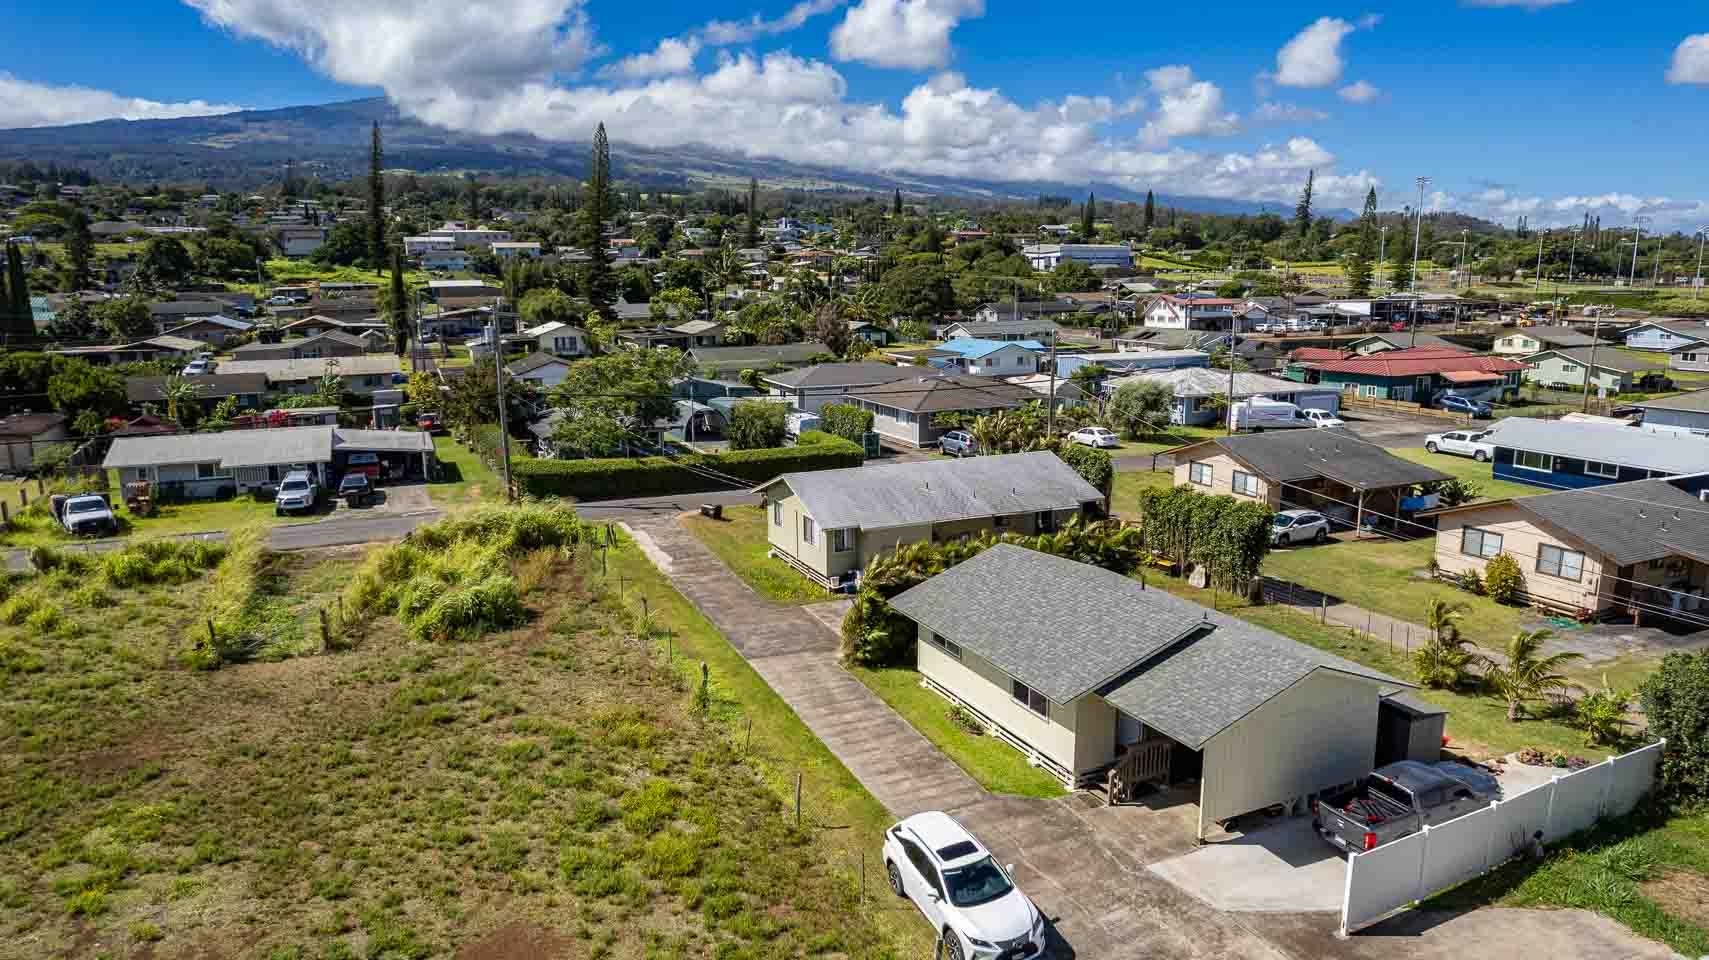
[884,811,1044,960]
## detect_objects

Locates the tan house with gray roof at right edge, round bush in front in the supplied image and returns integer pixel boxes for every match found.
[1434,473,1709,618]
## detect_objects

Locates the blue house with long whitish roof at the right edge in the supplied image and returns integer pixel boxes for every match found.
[1483,417,1709,490]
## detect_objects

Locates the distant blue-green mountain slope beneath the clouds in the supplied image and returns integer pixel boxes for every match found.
[0,97,1352,219]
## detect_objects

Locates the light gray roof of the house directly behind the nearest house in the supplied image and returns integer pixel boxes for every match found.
[761,451,1104,530]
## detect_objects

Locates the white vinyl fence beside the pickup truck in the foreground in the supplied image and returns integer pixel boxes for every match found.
[1342,741,1666,936]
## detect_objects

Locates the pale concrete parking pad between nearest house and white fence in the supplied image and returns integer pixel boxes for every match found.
[1150,817,1347,914]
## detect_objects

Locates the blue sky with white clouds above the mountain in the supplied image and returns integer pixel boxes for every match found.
[0,0,1709,229]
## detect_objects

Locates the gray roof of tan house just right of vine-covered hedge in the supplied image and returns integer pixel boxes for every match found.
[1178,427,1448,490]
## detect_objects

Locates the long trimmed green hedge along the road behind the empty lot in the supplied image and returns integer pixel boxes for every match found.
[511,437,863,500]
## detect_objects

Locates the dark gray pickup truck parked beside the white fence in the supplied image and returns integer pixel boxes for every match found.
[1311,760,1501,852]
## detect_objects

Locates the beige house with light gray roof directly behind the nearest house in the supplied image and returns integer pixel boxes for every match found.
[755,451,1104,588]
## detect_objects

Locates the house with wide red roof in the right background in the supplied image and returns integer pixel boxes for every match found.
[1287,347,1530,403]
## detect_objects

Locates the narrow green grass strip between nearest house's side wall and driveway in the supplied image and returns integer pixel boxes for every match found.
[849,666,1066,796]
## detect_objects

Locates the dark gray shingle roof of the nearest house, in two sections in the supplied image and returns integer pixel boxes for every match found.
[890,543,1405,748]
